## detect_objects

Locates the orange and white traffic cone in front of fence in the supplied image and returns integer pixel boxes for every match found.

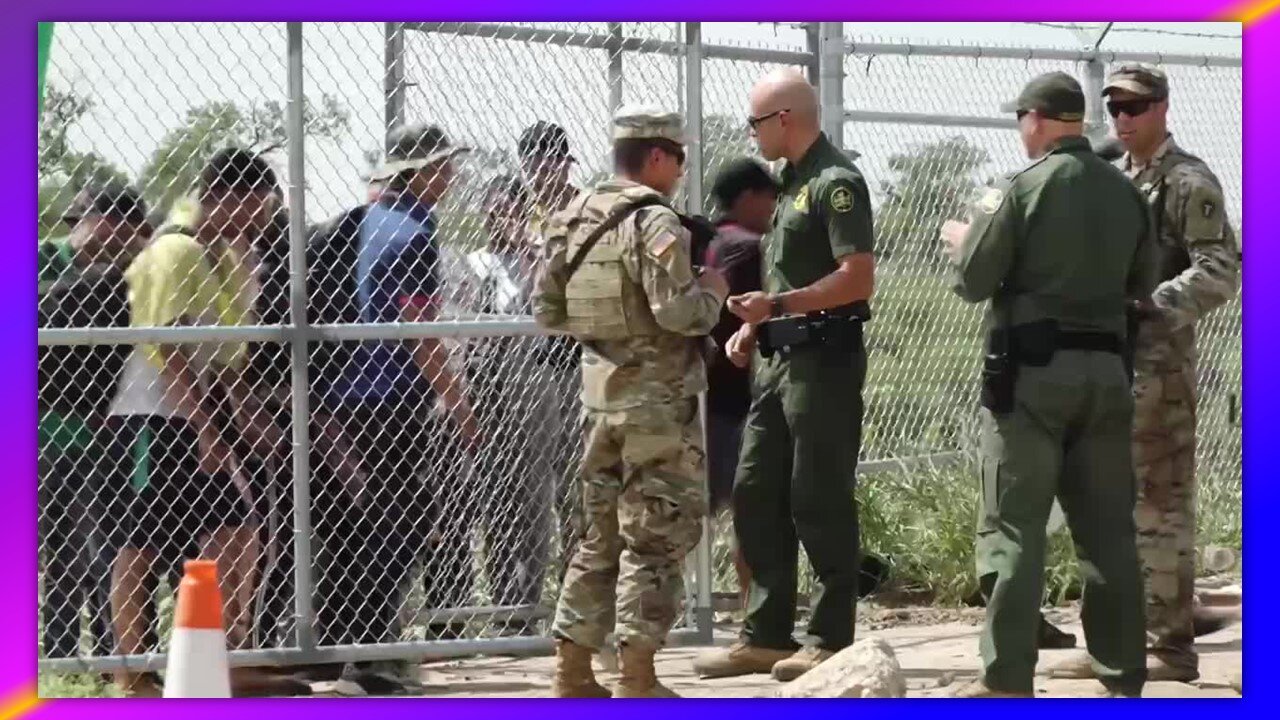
[164,560,232,697]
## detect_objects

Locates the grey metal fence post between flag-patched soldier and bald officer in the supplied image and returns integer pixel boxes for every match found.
[685,23,716,644]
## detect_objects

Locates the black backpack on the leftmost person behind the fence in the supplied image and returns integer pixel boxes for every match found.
[36,244,133,419]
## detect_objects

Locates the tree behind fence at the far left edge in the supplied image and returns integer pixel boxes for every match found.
[36,85,128,236]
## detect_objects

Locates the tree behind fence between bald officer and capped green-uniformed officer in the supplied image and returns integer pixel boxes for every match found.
[876,136,991,266]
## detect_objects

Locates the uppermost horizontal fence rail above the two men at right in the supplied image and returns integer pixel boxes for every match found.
[845,38,1243,68]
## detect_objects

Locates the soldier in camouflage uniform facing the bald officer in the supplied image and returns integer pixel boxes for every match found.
[532,109,728,697]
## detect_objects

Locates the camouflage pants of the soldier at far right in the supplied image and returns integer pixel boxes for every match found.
[1133,363,1197,667]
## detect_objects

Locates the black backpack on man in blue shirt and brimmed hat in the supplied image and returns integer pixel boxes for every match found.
[307,205,369,392]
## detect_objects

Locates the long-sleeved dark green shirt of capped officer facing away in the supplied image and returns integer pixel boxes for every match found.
[952,136,1156,334]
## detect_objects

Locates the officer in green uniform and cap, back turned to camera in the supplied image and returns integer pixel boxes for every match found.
[941,72,1156,697]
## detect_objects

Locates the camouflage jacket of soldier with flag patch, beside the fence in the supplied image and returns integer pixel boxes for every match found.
[532,179,724,411]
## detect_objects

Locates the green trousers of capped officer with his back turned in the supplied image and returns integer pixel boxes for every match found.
[977,350,1147,692]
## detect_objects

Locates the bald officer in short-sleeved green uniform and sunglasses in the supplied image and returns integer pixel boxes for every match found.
[695,70,874,680]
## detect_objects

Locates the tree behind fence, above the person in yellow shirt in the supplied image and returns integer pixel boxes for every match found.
[138,95,351,219]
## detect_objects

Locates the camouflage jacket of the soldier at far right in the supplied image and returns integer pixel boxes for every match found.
[1120,137,1240,372]
